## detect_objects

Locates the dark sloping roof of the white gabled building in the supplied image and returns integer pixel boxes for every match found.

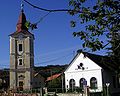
[68,50,118,71]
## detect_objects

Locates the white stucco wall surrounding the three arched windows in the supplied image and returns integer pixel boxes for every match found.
[64,53,102,91]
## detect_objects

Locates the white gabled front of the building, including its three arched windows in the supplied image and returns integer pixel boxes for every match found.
[64,53,103,92]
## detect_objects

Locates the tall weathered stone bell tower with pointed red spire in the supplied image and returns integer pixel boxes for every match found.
[10,9,34,91]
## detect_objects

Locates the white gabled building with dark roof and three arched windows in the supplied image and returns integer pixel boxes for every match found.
[64,51,120,93]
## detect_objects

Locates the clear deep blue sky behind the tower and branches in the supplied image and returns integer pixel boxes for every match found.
[0,0,106,69]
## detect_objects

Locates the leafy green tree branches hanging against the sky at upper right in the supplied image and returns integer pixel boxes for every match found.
[69,0,120,51]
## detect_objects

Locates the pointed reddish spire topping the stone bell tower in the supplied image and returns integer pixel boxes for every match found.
[16,1,28,32]
